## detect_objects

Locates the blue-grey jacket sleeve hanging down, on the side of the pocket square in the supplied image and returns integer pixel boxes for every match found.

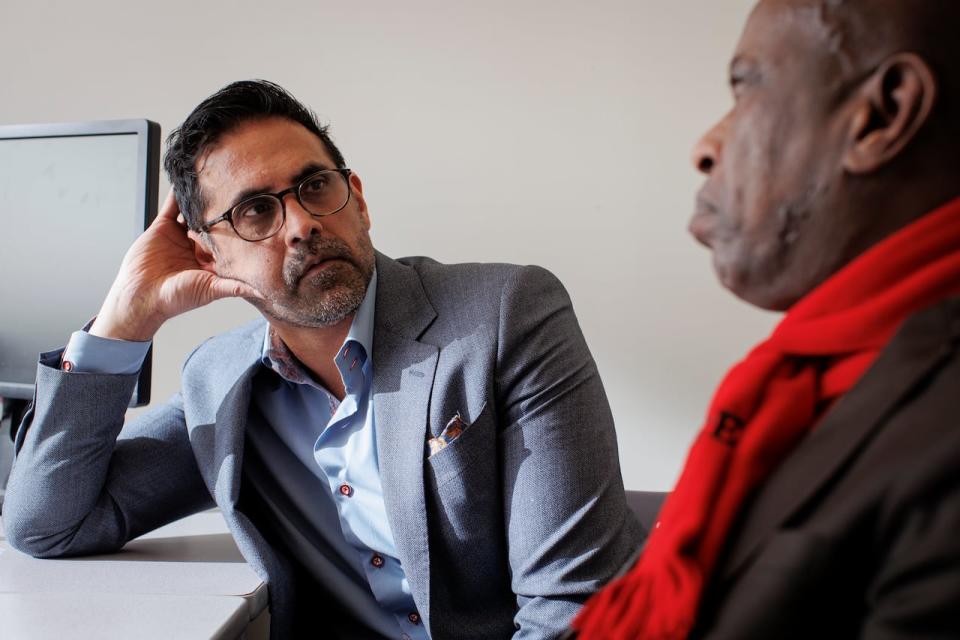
[497,267,643,639]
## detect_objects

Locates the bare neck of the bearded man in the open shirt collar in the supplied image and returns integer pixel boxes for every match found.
[270,314,354,400]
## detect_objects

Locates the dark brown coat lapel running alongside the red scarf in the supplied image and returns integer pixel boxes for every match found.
[718,305,957,579]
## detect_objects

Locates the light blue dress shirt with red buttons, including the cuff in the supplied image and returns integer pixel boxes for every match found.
[63,272,429,640]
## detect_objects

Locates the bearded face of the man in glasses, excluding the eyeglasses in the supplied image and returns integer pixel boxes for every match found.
[197,118,375,327]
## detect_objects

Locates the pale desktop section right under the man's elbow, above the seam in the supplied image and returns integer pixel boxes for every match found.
[0,511,267,620]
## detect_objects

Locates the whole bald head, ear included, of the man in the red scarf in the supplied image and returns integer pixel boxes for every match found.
[690,0,960,309]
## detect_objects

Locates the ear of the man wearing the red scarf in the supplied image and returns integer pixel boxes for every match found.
[844,53,938,174]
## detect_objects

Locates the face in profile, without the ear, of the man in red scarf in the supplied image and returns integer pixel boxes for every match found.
[690,0,849,310]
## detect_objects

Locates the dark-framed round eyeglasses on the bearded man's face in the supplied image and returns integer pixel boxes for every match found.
[197,169,350,242]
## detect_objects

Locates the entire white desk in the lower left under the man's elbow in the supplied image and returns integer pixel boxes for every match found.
[0,511,270,640]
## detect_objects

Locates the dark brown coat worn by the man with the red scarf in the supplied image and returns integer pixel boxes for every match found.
[693,299,960,640]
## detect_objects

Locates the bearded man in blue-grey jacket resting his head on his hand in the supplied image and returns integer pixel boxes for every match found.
[4,81,641,640]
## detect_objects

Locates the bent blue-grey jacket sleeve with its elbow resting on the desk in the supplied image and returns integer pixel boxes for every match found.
[3,352,212,557]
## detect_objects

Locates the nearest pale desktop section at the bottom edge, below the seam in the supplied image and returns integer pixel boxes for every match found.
[0,593,249,640]
